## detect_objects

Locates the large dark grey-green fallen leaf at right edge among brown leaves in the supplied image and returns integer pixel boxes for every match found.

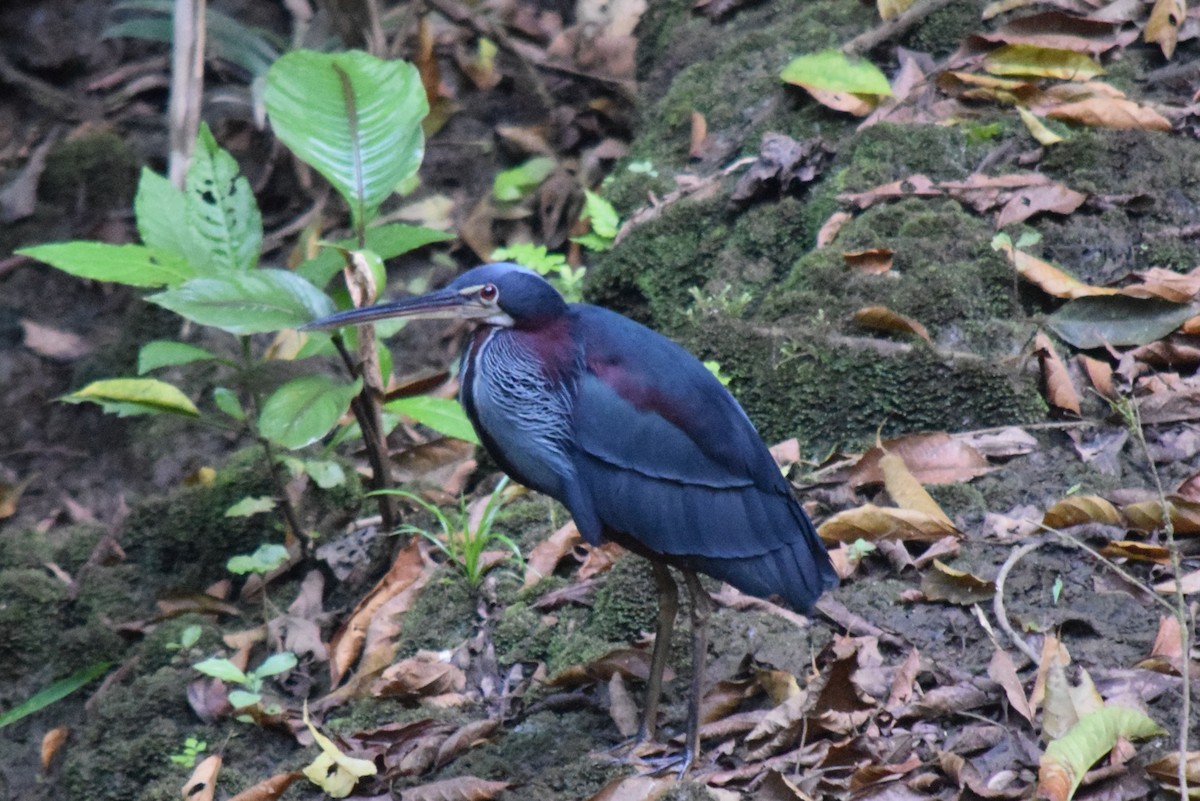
[1046,295,1196,350]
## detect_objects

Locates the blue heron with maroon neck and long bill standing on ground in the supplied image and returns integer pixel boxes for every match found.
[305,263,838,770]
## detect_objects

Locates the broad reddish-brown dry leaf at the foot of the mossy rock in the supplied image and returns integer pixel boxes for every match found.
[847,429,988,487]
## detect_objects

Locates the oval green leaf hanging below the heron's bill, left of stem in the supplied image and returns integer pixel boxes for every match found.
[258,375,362,448]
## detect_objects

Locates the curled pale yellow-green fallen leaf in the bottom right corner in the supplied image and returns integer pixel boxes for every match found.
[1038,706,1166,797]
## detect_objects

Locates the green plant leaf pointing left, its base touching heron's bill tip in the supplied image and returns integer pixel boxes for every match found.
[146,270,335,335]
